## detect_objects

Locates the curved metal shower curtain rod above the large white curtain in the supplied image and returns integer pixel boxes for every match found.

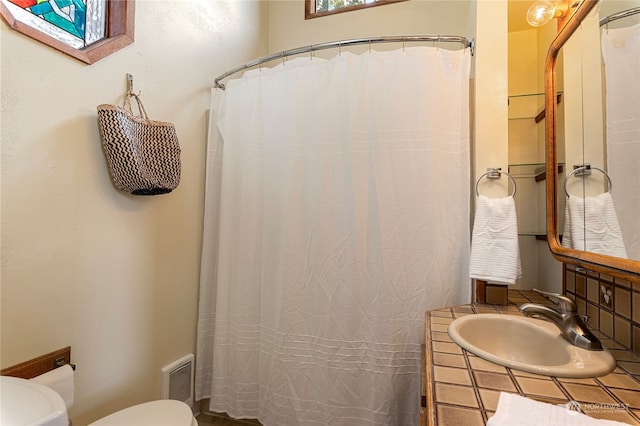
[214,34,475,90]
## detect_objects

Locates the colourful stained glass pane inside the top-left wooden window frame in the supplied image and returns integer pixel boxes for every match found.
[2,0,107,49]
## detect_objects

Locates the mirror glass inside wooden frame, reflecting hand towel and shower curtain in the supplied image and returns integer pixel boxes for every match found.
[552,0,640,263]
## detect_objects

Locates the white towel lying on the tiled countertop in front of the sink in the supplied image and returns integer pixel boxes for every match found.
[487,392,629,426]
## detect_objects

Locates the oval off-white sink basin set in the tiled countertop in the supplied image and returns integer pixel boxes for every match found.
[449,314,616,378]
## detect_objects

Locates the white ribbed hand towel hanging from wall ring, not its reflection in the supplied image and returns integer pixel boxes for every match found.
[469,195,522,284]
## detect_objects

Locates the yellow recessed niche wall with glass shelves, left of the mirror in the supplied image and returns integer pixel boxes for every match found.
[508,21,562,292]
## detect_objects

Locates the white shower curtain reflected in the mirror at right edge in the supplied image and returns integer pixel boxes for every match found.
[602,24,640,260]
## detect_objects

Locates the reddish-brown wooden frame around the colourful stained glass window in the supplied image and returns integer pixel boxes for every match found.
[0,0,135,64]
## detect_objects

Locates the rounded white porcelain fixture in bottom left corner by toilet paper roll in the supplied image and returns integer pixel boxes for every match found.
[0,376,69,426]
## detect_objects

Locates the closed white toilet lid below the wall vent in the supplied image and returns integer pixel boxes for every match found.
[90,399,193,426]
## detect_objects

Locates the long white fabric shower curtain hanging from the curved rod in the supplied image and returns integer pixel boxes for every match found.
[196,47,470,426]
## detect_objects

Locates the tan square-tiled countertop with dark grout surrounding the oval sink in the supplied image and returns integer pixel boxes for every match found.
[420,290,640,426]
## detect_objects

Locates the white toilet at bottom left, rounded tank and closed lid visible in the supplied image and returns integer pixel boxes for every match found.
[0,376,198,426]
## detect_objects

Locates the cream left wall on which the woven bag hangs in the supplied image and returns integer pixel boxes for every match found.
[0,0,268,425]
